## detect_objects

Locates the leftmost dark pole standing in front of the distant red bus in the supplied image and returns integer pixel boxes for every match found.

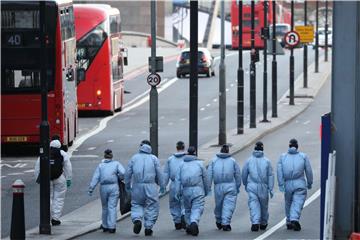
[237,1,244,134]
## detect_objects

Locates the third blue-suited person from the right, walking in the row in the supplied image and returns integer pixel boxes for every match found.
[207,145,241,231]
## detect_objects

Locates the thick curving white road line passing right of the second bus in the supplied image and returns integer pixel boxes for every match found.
[68,78,178,157]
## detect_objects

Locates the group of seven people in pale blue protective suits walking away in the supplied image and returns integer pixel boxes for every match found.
[83,139,313,236]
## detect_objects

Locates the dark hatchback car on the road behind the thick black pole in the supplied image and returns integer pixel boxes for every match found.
[176,48,215,78]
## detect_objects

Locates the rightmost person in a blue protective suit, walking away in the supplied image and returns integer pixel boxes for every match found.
[277,139,313,231]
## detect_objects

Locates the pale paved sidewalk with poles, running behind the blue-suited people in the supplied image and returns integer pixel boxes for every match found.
[15,56,331,240]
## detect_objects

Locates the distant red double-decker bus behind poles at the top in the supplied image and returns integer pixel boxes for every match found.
[230,0,272,49]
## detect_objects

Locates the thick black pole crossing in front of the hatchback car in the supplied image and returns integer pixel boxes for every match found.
[189,1,198,150]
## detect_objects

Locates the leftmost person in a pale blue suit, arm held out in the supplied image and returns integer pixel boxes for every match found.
[88,149,125,233]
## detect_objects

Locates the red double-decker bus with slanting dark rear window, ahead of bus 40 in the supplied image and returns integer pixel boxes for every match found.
[74,4,124,114]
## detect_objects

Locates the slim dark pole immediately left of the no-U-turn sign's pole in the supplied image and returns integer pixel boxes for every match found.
[271,0,277,118]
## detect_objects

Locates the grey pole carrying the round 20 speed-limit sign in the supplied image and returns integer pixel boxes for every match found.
[150,0,159,156]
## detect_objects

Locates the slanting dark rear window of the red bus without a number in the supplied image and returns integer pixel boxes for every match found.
[77,22,107,70]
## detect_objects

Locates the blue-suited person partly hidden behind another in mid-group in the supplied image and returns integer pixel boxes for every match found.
[164,141,186,230]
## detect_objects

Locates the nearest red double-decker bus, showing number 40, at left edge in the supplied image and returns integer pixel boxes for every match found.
[1,1,78,145]
